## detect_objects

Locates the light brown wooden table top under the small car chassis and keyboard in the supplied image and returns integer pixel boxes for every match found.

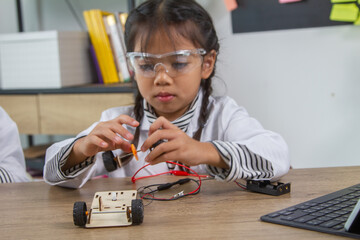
[0,167,360,240]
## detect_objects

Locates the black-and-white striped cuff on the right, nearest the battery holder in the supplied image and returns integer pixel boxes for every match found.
[207,141,274,182]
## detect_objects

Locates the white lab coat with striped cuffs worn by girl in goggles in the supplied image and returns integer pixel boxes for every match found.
[44,91,290,188]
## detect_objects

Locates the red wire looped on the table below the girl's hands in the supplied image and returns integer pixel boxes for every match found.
[131,161,207,200]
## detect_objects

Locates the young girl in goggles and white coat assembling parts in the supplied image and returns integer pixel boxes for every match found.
[44,0,289,188]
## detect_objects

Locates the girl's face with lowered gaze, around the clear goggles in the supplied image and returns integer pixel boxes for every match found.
[134,32,216,121]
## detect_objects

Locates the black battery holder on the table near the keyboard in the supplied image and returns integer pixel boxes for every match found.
[246,180,290,196]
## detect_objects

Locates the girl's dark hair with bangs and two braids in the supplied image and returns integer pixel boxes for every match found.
[125,0,219,141]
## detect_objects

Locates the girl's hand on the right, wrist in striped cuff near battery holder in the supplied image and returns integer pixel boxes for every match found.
[141,117,226,167]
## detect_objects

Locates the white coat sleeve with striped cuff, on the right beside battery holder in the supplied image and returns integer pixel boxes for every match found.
[207,97,290,181]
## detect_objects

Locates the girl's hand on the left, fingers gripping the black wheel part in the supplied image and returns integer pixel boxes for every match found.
[69,115,139,163]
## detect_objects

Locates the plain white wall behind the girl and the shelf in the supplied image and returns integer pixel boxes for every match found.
[0,0,360,168]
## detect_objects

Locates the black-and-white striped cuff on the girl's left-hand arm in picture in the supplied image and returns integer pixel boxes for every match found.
[45,138,94,183]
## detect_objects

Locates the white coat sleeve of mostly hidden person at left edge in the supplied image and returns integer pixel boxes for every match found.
[0,107,29,183]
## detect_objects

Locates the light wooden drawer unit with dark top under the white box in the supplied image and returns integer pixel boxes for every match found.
[0,83,134,135]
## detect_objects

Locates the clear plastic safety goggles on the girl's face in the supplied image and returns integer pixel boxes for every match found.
[126,48,206,78]
